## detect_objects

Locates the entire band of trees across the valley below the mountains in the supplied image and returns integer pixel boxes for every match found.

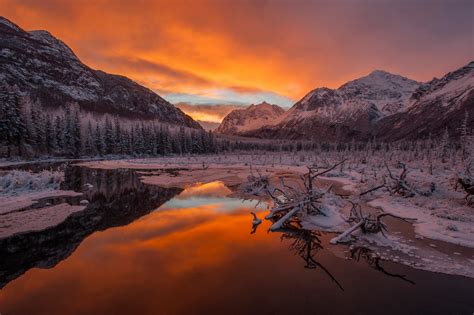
[0,83,474,160]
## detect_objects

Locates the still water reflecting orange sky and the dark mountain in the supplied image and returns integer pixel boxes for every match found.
[0,167,474,315]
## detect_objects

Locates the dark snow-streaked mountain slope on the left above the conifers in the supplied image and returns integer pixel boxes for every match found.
[0,17,201,129]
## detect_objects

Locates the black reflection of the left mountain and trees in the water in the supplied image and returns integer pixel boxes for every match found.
[0,167,182,288]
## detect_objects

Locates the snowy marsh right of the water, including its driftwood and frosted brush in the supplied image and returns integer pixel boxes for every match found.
[76,142,474,277]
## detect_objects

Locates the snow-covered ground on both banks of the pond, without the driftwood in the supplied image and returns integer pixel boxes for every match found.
[0,147,474,277]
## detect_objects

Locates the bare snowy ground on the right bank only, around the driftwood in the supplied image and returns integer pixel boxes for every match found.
[78,153,474,277]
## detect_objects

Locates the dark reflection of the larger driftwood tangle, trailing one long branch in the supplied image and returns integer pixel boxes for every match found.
[275,224,344,291]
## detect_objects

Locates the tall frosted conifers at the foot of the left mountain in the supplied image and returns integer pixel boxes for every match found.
[0,84,217,158]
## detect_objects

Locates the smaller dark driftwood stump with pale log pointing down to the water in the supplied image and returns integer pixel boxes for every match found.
[330,201,416,244]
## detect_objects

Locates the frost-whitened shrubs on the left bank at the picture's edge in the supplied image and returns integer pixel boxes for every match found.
[0,170,64,194]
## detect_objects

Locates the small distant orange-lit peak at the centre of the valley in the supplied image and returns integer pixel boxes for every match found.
[216,102,285,135]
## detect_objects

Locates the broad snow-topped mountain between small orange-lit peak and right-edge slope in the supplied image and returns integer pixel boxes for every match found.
[253,70,420,141]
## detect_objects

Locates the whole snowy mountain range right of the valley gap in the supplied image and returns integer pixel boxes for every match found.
[217,62,474,141]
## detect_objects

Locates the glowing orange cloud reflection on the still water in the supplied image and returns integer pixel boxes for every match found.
[0,206,271,314]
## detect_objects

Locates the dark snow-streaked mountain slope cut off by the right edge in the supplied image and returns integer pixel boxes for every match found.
[377,61,474,141]
